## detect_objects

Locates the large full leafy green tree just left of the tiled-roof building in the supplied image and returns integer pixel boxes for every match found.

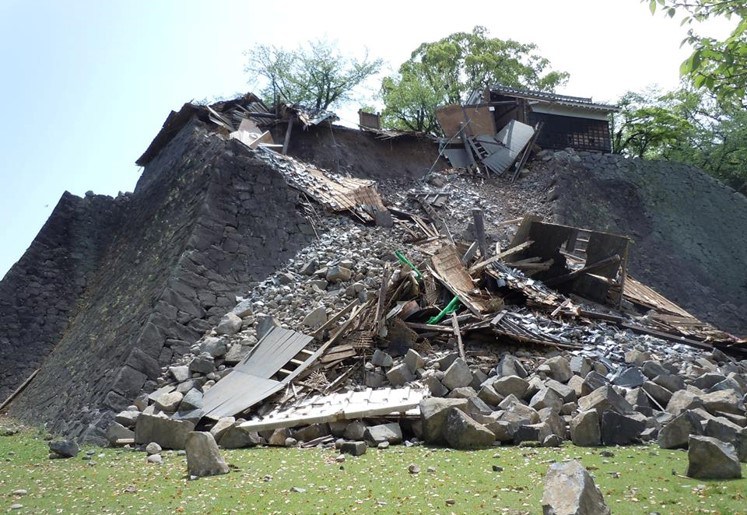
[382,26,568,132]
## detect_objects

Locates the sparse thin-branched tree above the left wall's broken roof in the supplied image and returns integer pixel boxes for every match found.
[245,40,382,109]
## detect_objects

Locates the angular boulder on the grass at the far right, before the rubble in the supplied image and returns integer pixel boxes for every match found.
[687,436,742,479]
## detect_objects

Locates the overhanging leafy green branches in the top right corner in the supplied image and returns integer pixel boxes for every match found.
[642,0,747,108]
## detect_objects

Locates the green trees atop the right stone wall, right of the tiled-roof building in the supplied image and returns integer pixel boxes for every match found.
[612,84,747,194]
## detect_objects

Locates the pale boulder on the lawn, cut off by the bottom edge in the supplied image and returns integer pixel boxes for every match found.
[542,460,610,515]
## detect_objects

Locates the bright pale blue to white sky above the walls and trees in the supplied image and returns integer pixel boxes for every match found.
[0,0,732,277]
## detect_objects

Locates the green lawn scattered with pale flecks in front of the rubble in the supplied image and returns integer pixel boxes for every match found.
[0,424,747,514]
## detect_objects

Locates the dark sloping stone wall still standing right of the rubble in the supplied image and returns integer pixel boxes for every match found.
[544,152,747,336]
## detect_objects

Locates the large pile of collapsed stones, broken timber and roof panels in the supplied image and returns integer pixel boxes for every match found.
[108,142,747,480]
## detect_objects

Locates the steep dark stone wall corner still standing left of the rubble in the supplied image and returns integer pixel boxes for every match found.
[3,120,313,441]
